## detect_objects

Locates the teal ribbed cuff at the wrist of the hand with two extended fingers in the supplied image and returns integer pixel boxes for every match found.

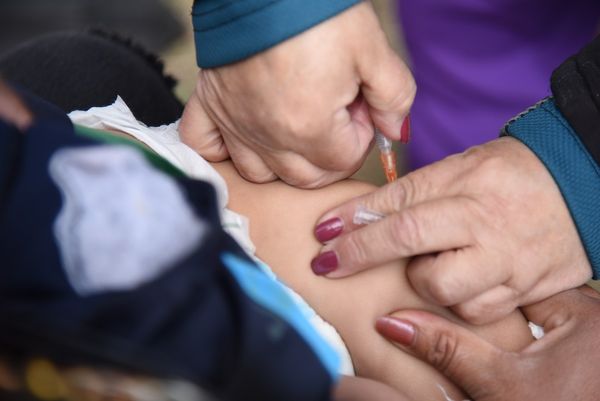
[502,98,600,279]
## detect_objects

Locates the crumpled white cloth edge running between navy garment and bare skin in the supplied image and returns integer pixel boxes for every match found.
[69,97,354,375]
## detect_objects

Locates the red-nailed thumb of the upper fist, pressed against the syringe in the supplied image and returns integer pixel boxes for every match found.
[359,38,416,143]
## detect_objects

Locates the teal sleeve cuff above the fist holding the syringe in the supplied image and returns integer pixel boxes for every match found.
[192,0,361,68]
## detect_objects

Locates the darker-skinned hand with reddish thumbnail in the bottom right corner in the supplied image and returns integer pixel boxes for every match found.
[376,287,600,401]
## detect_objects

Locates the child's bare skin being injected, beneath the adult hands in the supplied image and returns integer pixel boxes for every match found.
[213,162,532,400]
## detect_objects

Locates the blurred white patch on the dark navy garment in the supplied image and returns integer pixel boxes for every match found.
[49,145,208,295]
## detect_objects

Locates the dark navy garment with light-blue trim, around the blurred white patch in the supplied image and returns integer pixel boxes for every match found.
[0,90,338,401]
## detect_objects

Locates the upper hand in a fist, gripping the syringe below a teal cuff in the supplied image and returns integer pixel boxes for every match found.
[179,2,416,188]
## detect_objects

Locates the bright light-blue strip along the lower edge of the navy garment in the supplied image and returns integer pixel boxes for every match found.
[221,253,341,382]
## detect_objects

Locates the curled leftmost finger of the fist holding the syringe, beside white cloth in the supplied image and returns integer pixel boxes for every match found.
[179,85,229,162]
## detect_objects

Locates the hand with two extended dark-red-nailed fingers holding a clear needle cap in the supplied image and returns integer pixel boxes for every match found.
[312,138,592,324]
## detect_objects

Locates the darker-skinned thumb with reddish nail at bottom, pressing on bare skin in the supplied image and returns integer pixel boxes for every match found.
[375,311,508,400]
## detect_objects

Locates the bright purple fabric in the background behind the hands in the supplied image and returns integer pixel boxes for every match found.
[398,0,600,168]
